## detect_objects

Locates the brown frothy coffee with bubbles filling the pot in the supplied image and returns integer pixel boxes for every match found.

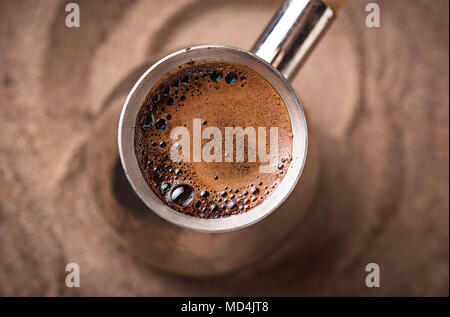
[134,60,293,218]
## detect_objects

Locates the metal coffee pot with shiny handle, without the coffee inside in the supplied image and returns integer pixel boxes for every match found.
[114,0,335,276]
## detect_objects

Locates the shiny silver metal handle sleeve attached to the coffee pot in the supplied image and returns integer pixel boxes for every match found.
[252,0,335,79]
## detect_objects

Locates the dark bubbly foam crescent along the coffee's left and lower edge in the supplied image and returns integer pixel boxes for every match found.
[135,62,292,218]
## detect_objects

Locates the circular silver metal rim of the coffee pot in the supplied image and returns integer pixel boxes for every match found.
[118,45,308,233]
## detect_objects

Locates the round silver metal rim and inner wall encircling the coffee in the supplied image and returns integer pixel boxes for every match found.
[118,45,308,232]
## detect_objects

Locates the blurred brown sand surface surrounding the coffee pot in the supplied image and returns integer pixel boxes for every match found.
[0,0,449,296]
